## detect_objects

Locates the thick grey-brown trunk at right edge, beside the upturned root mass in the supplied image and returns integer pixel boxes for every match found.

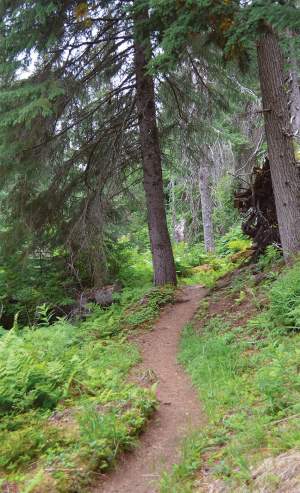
[257,29,300,260]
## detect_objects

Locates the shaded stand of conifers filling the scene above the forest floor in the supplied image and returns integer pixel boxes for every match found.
[0,1,300,326]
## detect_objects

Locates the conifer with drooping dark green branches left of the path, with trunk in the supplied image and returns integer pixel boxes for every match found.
[0,0,176,284]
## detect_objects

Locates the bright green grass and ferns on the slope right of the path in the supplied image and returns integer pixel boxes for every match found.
[160,252,300,493]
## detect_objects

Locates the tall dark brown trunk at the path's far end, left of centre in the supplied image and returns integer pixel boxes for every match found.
[134,9,176,286]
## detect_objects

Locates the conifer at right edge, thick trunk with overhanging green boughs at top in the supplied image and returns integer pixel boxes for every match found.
[153,0,300,258]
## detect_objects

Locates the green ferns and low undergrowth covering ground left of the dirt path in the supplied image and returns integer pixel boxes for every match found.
[0,287,174,493]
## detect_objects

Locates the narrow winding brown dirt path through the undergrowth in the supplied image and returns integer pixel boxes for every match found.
[93,286,207,493]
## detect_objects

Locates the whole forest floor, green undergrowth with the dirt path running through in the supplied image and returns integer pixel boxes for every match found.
[0,249,300,493]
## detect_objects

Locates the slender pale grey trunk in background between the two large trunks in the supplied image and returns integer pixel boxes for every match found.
[199,165,215,252]
